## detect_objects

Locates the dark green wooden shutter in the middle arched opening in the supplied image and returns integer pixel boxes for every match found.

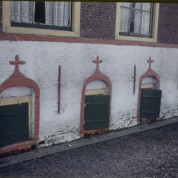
[84,95,110,130]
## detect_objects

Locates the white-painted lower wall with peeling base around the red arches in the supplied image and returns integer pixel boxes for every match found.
[0,41,178,146]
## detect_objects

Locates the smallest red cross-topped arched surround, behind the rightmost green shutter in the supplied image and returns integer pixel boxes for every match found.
[137,57,160,122]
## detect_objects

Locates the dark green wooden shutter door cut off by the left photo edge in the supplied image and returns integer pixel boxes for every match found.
[0,103,29,147]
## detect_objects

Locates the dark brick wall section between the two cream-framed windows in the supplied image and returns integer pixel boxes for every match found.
[80,2,116,39]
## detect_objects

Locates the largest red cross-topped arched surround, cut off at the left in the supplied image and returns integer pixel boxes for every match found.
[0,55,40,154]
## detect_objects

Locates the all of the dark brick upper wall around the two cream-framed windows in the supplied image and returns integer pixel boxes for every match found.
[0,1,178,44]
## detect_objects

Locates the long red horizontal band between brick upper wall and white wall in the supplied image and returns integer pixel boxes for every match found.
[0,34,178,48]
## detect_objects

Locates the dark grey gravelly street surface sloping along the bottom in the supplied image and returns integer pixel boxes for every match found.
[0,123,178,178]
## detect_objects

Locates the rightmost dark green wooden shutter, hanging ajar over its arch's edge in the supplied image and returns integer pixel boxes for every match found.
[140,89,162,118]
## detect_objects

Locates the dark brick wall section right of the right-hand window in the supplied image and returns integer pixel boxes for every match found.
[158,3,178,44]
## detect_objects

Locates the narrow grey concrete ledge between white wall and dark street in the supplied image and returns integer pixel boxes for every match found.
[0,117,178,168]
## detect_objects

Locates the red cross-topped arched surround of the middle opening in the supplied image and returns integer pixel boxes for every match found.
[80,56,112,135]
